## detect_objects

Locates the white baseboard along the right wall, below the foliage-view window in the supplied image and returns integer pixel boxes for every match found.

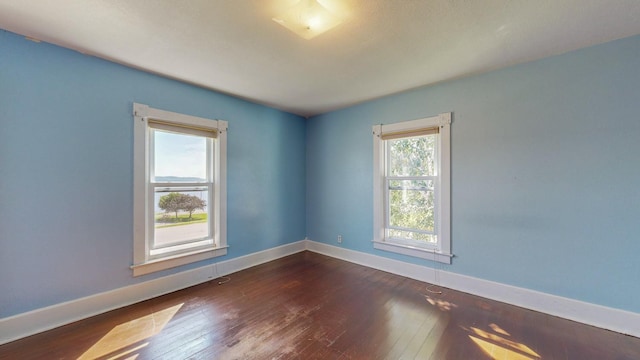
[306,240,640,337]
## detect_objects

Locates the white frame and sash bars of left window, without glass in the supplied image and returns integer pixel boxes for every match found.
[131,103,228,276]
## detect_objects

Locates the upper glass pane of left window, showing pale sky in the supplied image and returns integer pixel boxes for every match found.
[152,129,212,182]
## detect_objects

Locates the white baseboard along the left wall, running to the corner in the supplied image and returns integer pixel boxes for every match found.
[0,240,307,345]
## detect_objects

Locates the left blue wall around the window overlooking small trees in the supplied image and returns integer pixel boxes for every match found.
[0,30,306,318]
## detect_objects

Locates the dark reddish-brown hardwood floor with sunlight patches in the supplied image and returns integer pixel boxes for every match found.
[0,252,640,360]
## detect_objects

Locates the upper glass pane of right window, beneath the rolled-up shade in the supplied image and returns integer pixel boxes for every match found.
[386,134,437,176]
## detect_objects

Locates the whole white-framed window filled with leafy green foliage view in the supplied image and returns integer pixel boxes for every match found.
[373,113,452,264]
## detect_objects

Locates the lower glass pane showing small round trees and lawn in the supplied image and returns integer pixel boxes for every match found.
[152,187,211,248]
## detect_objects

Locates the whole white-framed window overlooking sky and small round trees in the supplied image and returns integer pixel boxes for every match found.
[132,104,227,276]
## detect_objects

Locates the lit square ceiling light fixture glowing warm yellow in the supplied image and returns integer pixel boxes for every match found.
[273,0,342,40]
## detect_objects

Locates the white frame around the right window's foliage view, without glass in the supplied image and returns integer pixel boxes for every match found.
[373,113,453,264]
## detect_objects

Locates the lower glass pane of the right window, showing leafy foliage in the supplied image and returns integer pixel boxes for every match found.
[389,180,434,232]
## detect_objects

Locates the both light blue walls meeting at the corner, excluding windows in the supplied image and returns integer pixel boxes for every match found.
[0,31,640,318]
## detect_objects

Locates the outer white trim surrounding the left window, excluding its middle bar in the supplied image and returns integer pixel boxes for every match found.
[131,103,228,276]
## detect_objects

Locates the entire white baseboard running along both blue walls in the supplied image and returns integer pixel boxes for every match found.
[0,240,640,345]
